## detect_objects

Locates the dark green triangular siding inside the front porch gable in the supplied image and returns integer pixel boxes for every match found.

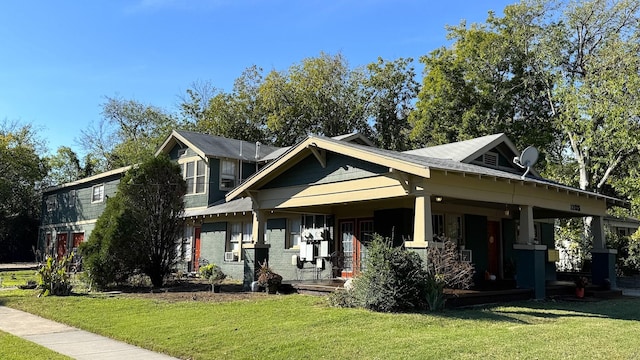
[264,152,389,189]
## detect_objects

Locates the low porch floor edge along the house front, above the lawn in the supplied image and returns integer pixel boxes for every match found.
[283,279,622,308]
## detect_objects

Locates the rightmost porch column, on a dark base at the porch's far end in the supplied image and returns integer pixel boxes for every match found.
[591,216,618,288]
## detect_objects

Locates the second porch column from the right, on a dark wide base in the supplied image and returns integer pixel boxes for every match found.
[513,205,547,299]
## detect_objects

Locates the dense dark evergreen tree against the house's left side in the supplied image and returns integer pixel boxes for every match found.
[81,156,186,287]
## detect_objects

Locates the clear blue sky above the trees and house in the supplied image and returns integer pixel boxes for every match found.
[0,0,515,152]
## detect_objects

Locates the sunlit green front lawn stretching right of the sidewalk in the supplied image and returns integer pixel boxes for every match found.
[0,290,640,359]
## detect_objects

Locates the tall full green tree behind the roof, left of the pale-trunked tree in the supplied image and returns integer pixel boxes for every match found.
[410,5,555,150]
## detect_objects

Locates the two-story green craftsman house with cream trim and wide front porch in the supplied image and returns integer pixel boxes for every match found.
[41,131,628,297]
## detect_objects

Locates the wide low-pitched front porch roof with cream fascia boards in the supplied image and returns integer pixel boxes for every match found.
[226,134,627,206]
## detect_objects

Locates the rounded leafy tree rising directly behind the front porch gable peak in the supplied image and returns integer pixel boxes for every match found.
[259,53,371,146]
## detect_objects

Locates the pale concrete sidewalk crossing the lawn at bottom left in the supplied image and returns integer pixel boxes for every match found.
[0,306,176,360]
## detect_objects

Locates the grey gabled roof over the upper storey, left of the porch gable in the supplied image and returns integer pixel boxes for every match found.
[156,130,279,161]
